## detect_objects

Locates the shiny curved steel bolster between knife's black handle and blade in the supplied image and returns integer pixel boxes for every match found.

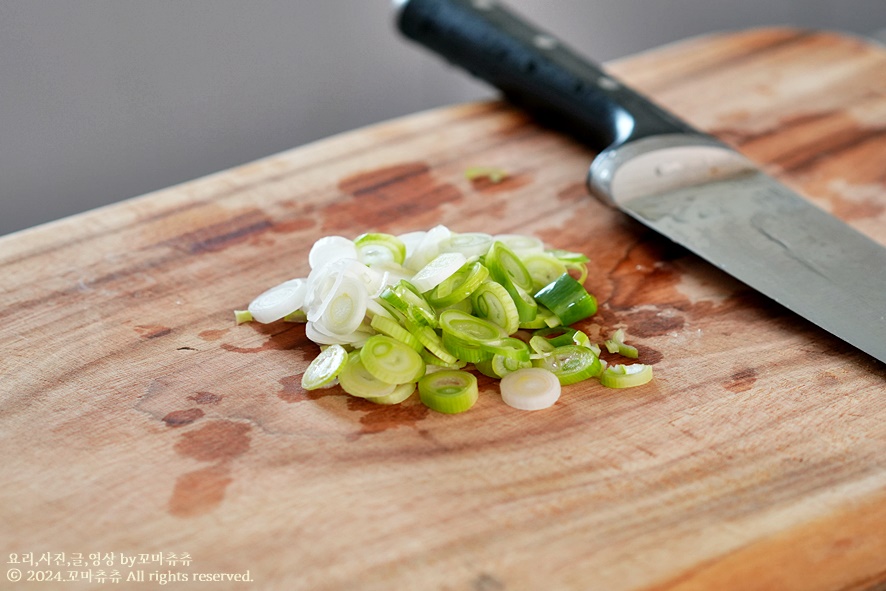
[587,134,755,207]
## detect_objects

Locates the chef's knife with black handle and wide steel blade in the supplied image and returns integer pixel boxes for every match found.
[394,0,886,362]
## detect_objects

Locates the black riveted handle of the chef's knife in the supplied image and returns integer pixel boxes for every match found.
[398,0,698,151]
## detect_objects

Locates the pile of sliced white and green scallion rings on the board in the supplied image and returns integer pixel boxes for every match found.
[235,226,652,414]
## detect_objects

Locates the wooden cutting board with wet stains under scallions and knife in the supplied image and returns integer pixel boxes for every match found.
[0,29,886,591]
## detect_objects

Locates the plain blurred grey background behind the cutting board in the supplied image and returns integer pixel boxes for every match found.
[0,0,886,234]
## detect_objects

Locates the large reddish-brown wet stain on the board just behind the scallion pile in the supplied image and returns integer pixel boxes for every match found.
[332,162,462,231]
